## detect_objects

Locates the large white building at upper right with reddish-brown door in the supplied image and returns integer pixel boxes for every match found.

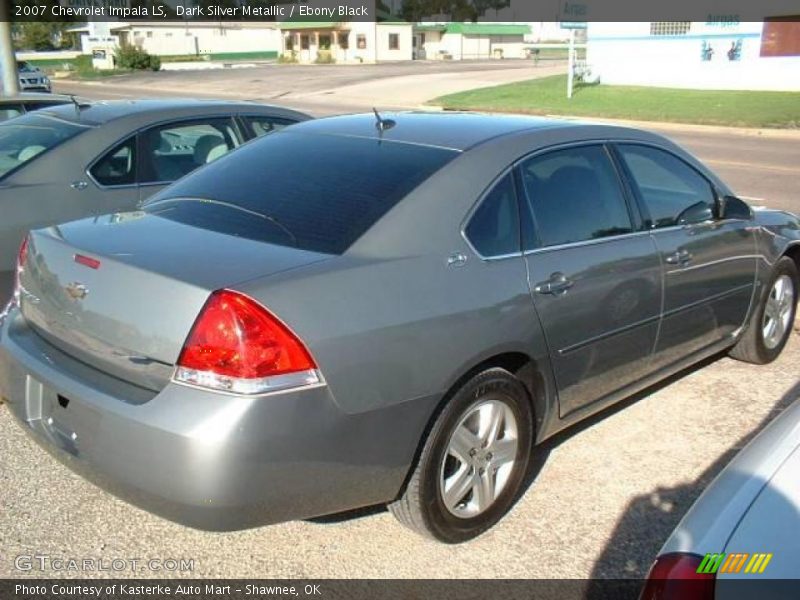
[586,17,800,91]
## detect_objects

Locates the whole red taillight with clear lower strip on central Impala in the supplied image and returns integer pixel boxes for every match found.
[175,290,321,394]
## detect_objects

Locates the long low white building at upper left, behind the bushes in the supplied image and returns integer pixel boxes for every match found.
[71,21,281,60]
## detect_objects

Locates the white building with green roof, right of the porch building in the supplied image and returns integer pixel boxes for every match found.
[414,23,531,60]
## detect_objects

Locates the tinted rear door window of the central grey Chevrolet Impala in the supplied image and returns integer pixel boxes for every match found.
[521,146,633,246]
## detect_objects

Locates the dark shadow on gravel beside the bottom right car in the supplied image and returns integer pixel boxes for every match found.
[587,381,800,598]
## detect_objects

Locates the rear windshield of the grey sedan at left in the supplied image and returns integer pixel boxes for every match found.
[0,115,86,178]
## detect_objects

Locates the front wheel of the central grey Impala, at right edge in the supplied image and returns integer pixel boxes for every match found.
[730,256,797,365]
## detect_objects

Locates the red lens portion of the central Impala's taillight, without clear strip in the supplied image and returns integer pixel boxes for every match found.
[178,290,316,379]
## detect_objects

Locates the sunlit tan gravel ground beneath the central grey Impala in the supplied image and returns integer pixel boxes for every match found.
[0,324,800,579]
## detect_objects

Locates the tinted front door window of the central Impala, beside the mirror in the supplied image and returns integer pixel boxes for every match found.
[619,144,715,227]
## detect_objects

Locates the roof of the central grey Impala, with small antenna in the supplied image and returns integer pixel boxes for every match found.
[284,111,604,151]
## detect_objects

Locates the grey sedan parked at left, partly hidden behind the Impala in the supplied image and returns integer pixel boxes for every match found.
[0,100,309,304]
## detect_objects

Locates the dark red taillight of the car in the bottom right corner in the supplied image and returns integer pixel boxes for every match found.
[639,552,715,600]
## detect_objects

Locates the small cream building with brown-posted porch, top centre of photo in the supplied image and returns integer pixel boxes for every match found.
[278,21,412,63]
